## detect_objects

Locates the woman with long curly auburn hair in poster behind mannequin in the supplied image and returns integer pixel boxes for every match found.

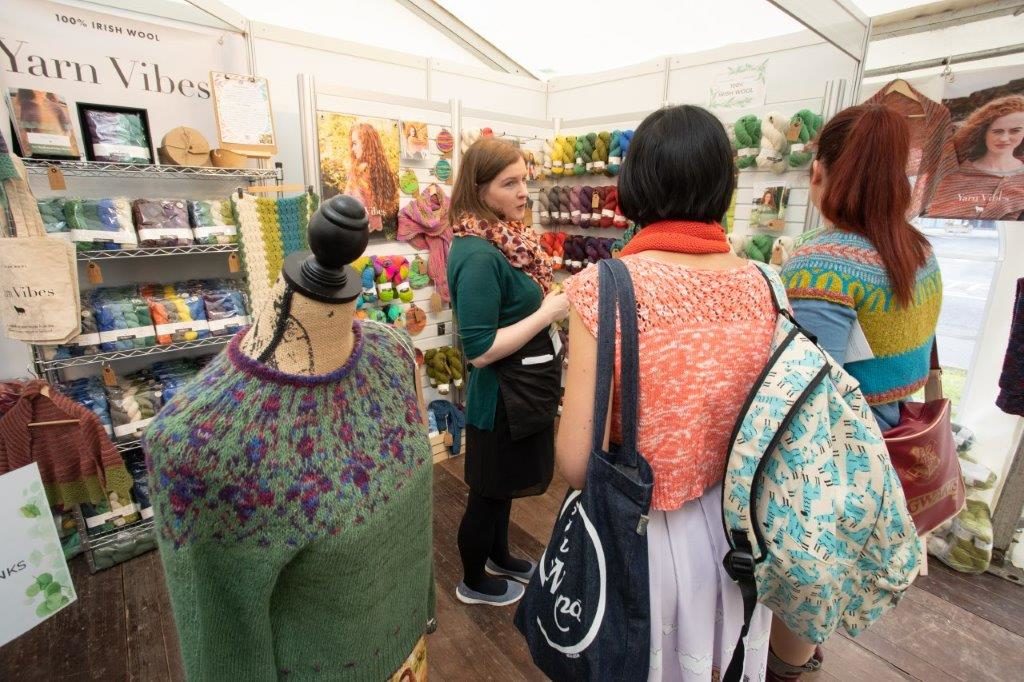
[344,123,398,237]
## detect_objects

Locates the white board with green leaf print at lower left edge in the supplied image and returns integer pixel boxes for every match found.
[0,463,78,646]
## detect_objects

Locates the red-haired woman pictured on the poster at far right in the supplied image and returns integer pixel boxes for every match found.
[927,95,1024,220]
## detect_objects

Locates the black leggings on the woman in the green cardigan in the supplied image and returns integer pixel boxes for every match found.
[459,491,512,590]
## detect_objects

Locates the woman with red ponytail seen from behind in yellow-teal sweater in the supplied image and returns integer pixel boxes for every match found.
[768,104,942,680]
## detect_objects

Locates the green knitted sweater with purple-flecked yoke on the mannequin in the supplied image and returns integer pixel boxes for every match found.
[144,322,433,682]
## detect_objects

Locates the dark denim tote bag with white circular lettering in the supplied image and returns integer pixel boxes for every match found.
[515,260,654,682]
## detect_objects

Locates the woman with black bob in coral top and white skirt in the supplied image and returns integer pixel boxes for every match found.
[555,105,775,680]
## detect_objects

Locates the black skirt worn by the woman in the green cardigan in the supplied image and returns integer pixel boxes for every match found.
[466,394,555,500]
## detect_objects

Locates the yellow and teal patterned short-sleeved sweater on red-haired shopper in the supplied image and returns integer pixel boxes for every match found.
[782,229,942,406]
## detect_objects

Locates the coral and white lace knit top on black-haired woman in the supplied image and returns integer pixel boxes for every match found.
[565,254,775,511]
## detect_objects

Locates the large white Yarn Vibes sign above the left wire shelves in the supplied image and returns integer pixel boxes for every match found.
[0,0,246,140]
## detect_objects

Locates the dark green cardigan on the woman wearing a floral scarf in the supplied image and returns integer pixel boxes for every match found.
[447,237,544,431]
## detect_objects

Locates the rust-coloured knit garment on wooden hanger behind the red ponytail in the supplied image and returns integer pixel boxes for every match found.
[865,81,956,218]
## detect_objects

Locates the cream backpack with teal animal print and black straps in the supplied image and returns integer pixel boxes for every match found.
[722,263,922,682]
